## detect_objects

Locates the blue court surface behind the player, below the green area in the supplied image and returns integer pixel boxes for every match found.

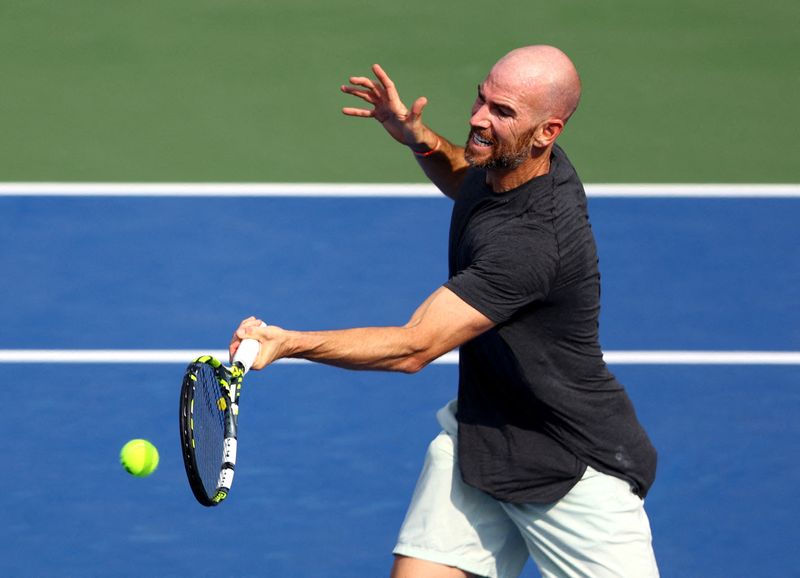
[0,187,800,578]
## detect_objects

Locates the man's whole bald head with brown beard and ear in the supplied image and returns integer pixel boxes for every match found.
[465,46,581,170]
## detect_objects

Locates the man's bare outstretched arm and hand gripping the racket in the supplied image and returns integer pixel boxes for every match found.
[230,287,494,373]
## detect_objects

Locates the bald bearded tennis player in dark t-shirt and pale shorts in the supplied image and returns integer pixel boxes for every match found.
[231,46,658,578]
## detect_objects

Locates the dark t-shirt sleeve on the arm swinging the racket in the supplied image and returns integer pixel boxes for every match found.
[445,229,558,324]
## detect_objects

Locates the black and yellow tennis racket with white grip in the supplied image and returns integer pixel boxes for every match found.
[180,332,260,507]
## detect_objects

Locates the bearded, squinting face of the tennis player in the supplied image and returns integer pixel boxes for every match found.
[464,75,536,170]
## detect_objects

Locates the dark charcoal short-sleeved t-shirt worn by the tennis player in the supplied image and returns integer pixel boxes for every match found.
[445,147,656,503]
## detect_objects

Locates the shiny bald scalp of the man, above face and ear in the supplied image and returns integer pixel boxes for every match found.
[489,45,581,122]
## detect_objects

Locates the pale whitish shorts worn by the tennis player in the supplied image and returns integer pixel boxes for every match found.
[394,402,658,578]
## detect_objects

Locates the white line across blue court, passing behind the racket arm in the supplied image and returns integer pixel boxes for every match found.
[0,349,800,365]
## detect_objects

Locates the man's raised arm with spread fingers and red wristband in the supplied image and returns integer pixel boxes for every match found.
[342,64,469,199]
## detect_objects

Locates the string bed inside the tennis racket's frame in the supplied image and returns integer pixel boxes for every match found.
[192,365,225,497]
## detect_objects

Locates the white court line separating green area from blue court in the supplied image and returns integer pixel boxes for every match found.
[0,182,800,199]
